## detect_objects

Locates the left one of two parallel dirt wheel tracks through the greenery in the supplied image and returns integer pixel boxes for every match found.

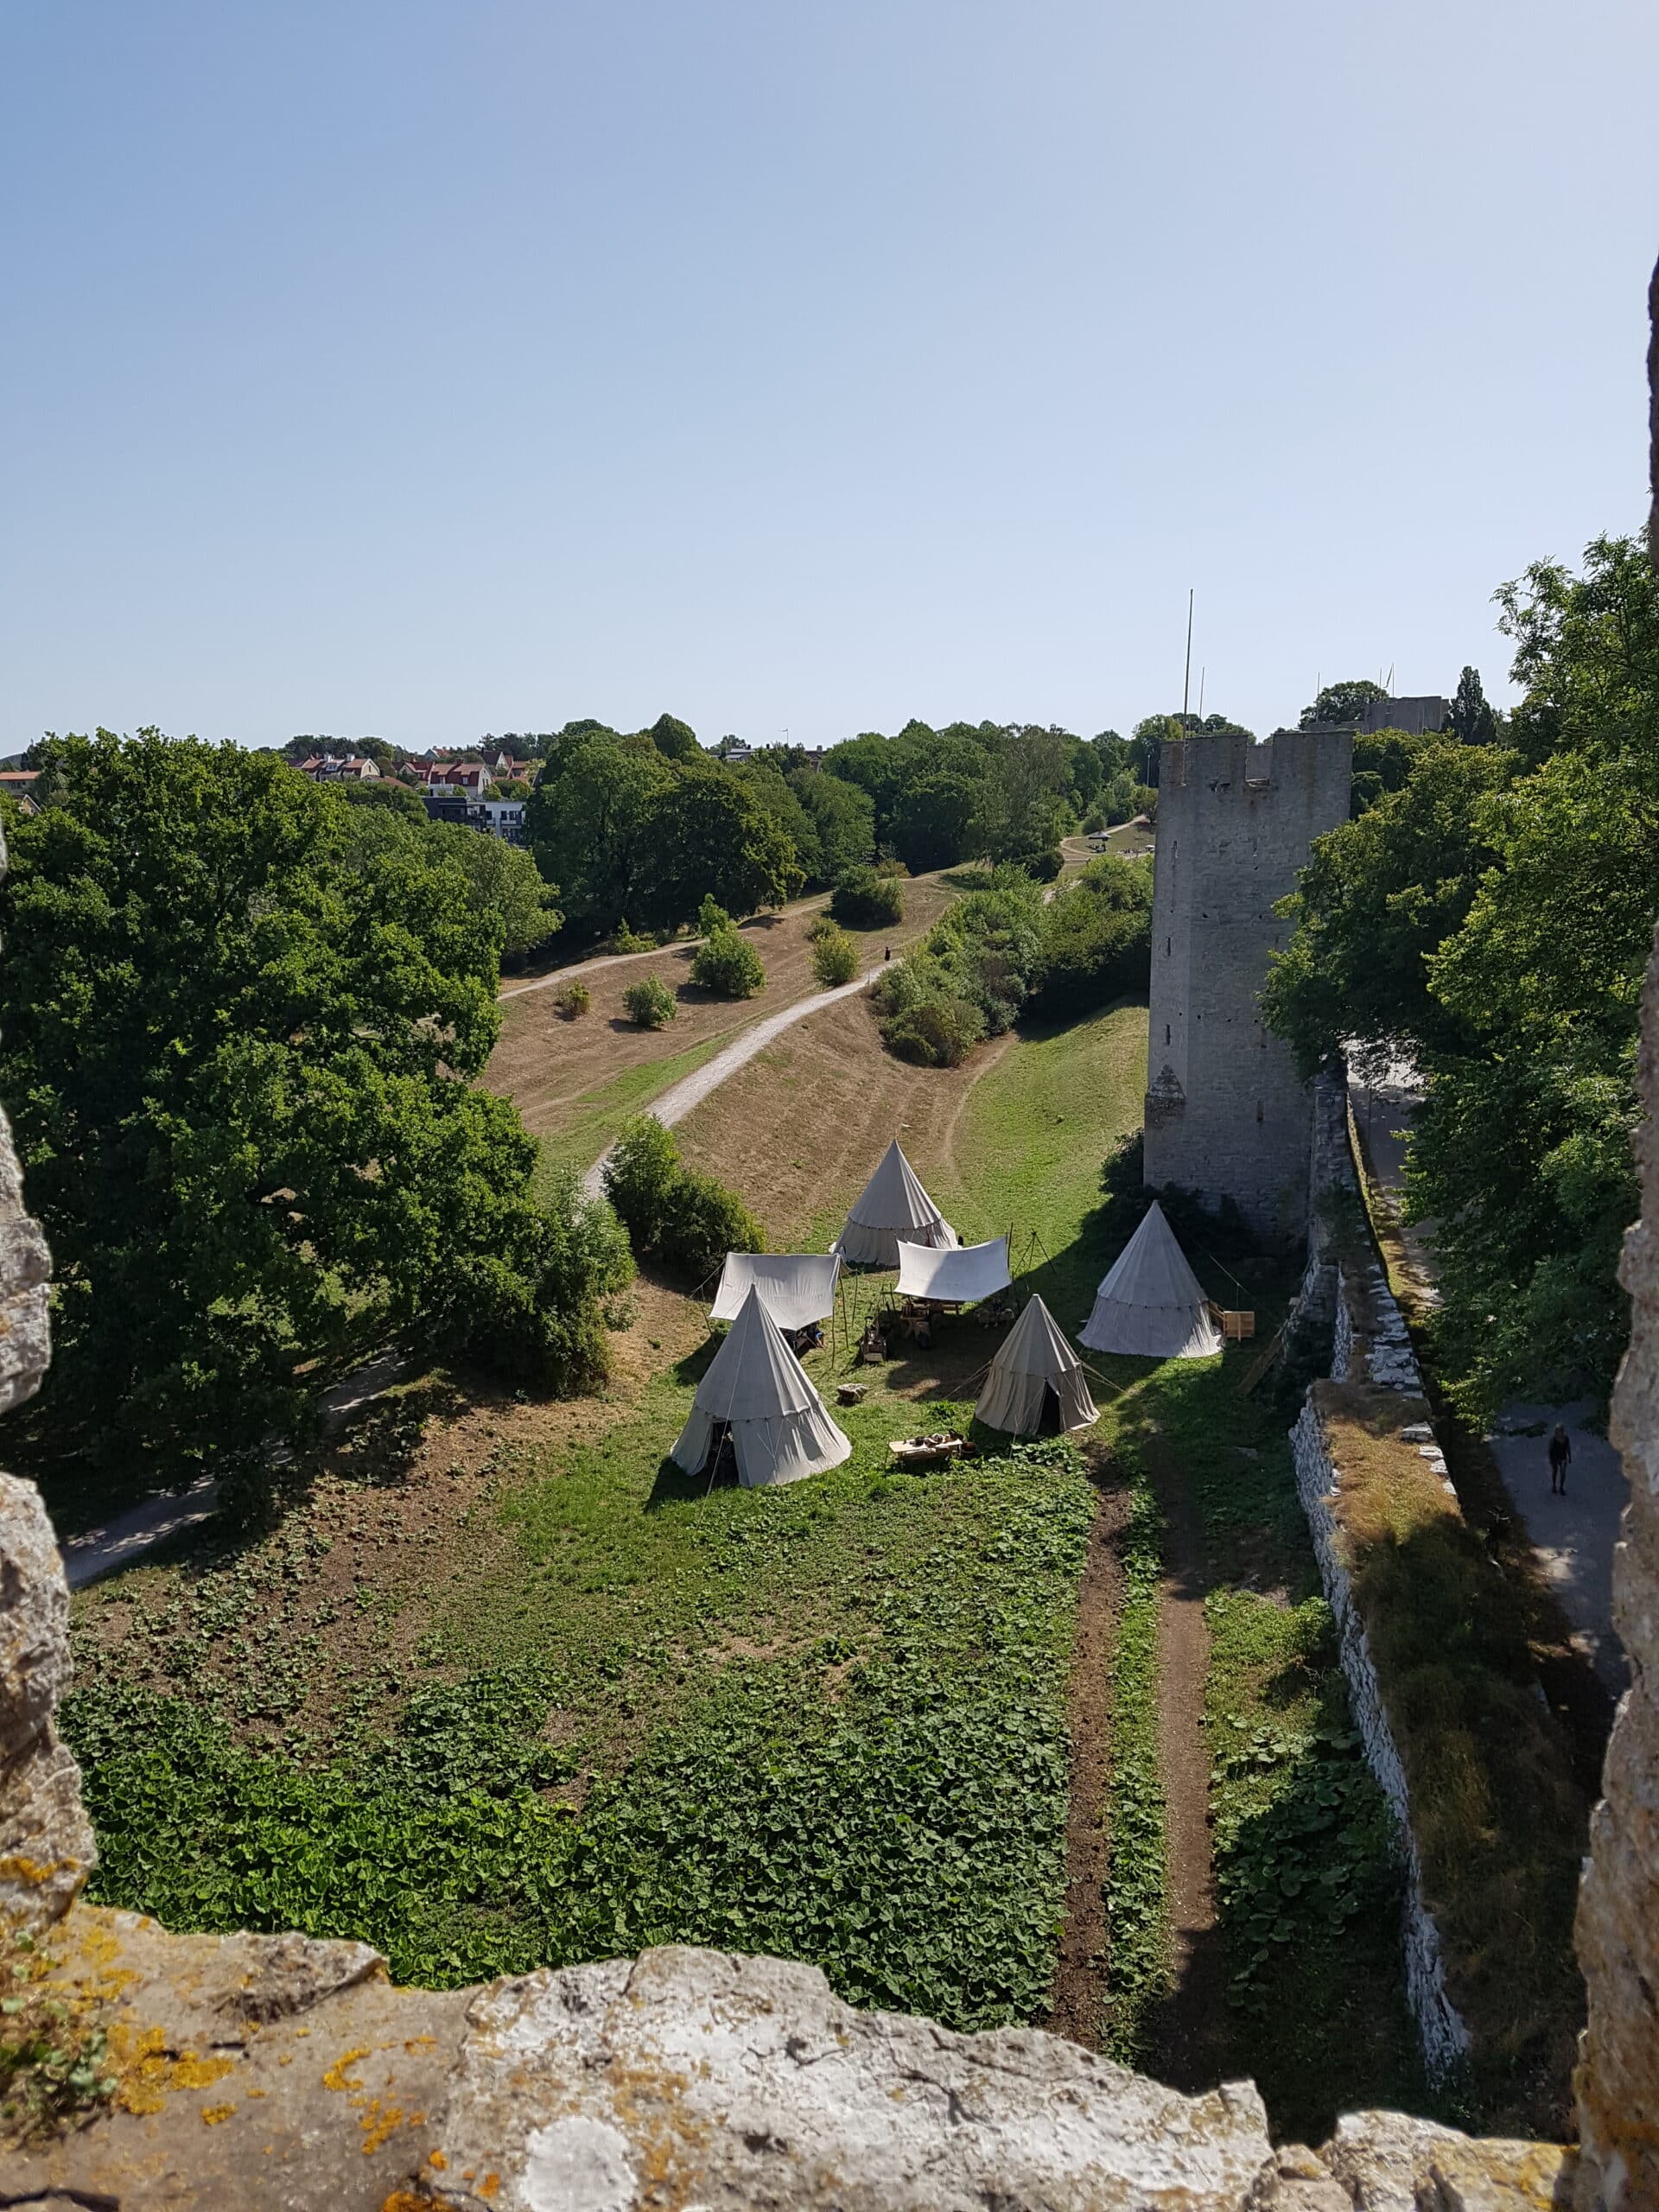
[1044,1451,1128,2050]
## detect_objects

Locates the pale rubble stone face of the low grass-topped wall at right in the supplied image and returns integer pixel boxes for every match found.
[1289,1389,1469,2082]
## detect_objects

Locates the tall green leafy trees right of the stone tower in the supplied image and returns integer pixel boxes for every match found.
[1263,537,1659,1411]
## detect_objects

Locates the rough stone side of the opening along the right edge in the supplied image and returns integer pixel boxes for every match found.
[1575,919,1659,2212]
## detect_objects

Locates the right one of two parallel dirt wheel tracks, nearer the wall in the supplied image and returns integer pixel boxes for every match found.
[1146,1433,1225,2090]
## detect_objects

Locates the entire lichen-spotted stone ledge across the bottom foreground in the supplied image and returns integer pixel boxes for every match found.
[0,1907,1571,2212]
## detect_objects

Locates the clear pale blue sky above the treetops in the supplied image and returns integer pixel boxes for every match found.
[0,0,1659,750]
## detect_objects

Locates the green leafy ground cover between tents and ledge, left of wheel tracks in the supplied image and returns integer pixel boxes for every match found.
[64,1422,1093,2026]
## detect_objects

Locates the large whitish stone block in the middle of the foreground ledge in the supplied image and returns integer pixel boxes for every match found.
[423,1948,1274,2212]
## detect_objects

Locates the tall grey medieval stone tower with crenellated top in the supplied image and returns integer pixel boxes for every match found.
[1146,728,1354,1239]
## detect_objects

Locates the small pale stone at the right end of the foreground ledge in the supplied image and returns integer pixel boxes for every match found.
[1320,2113,1577,2212]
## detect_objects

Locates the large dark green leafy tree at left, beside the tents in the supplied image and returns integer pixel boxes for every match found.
[0,732,626,1469]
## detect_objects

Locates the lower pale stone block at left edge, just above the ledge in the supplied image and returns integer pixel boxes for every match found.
[0,1476,98,1927]
